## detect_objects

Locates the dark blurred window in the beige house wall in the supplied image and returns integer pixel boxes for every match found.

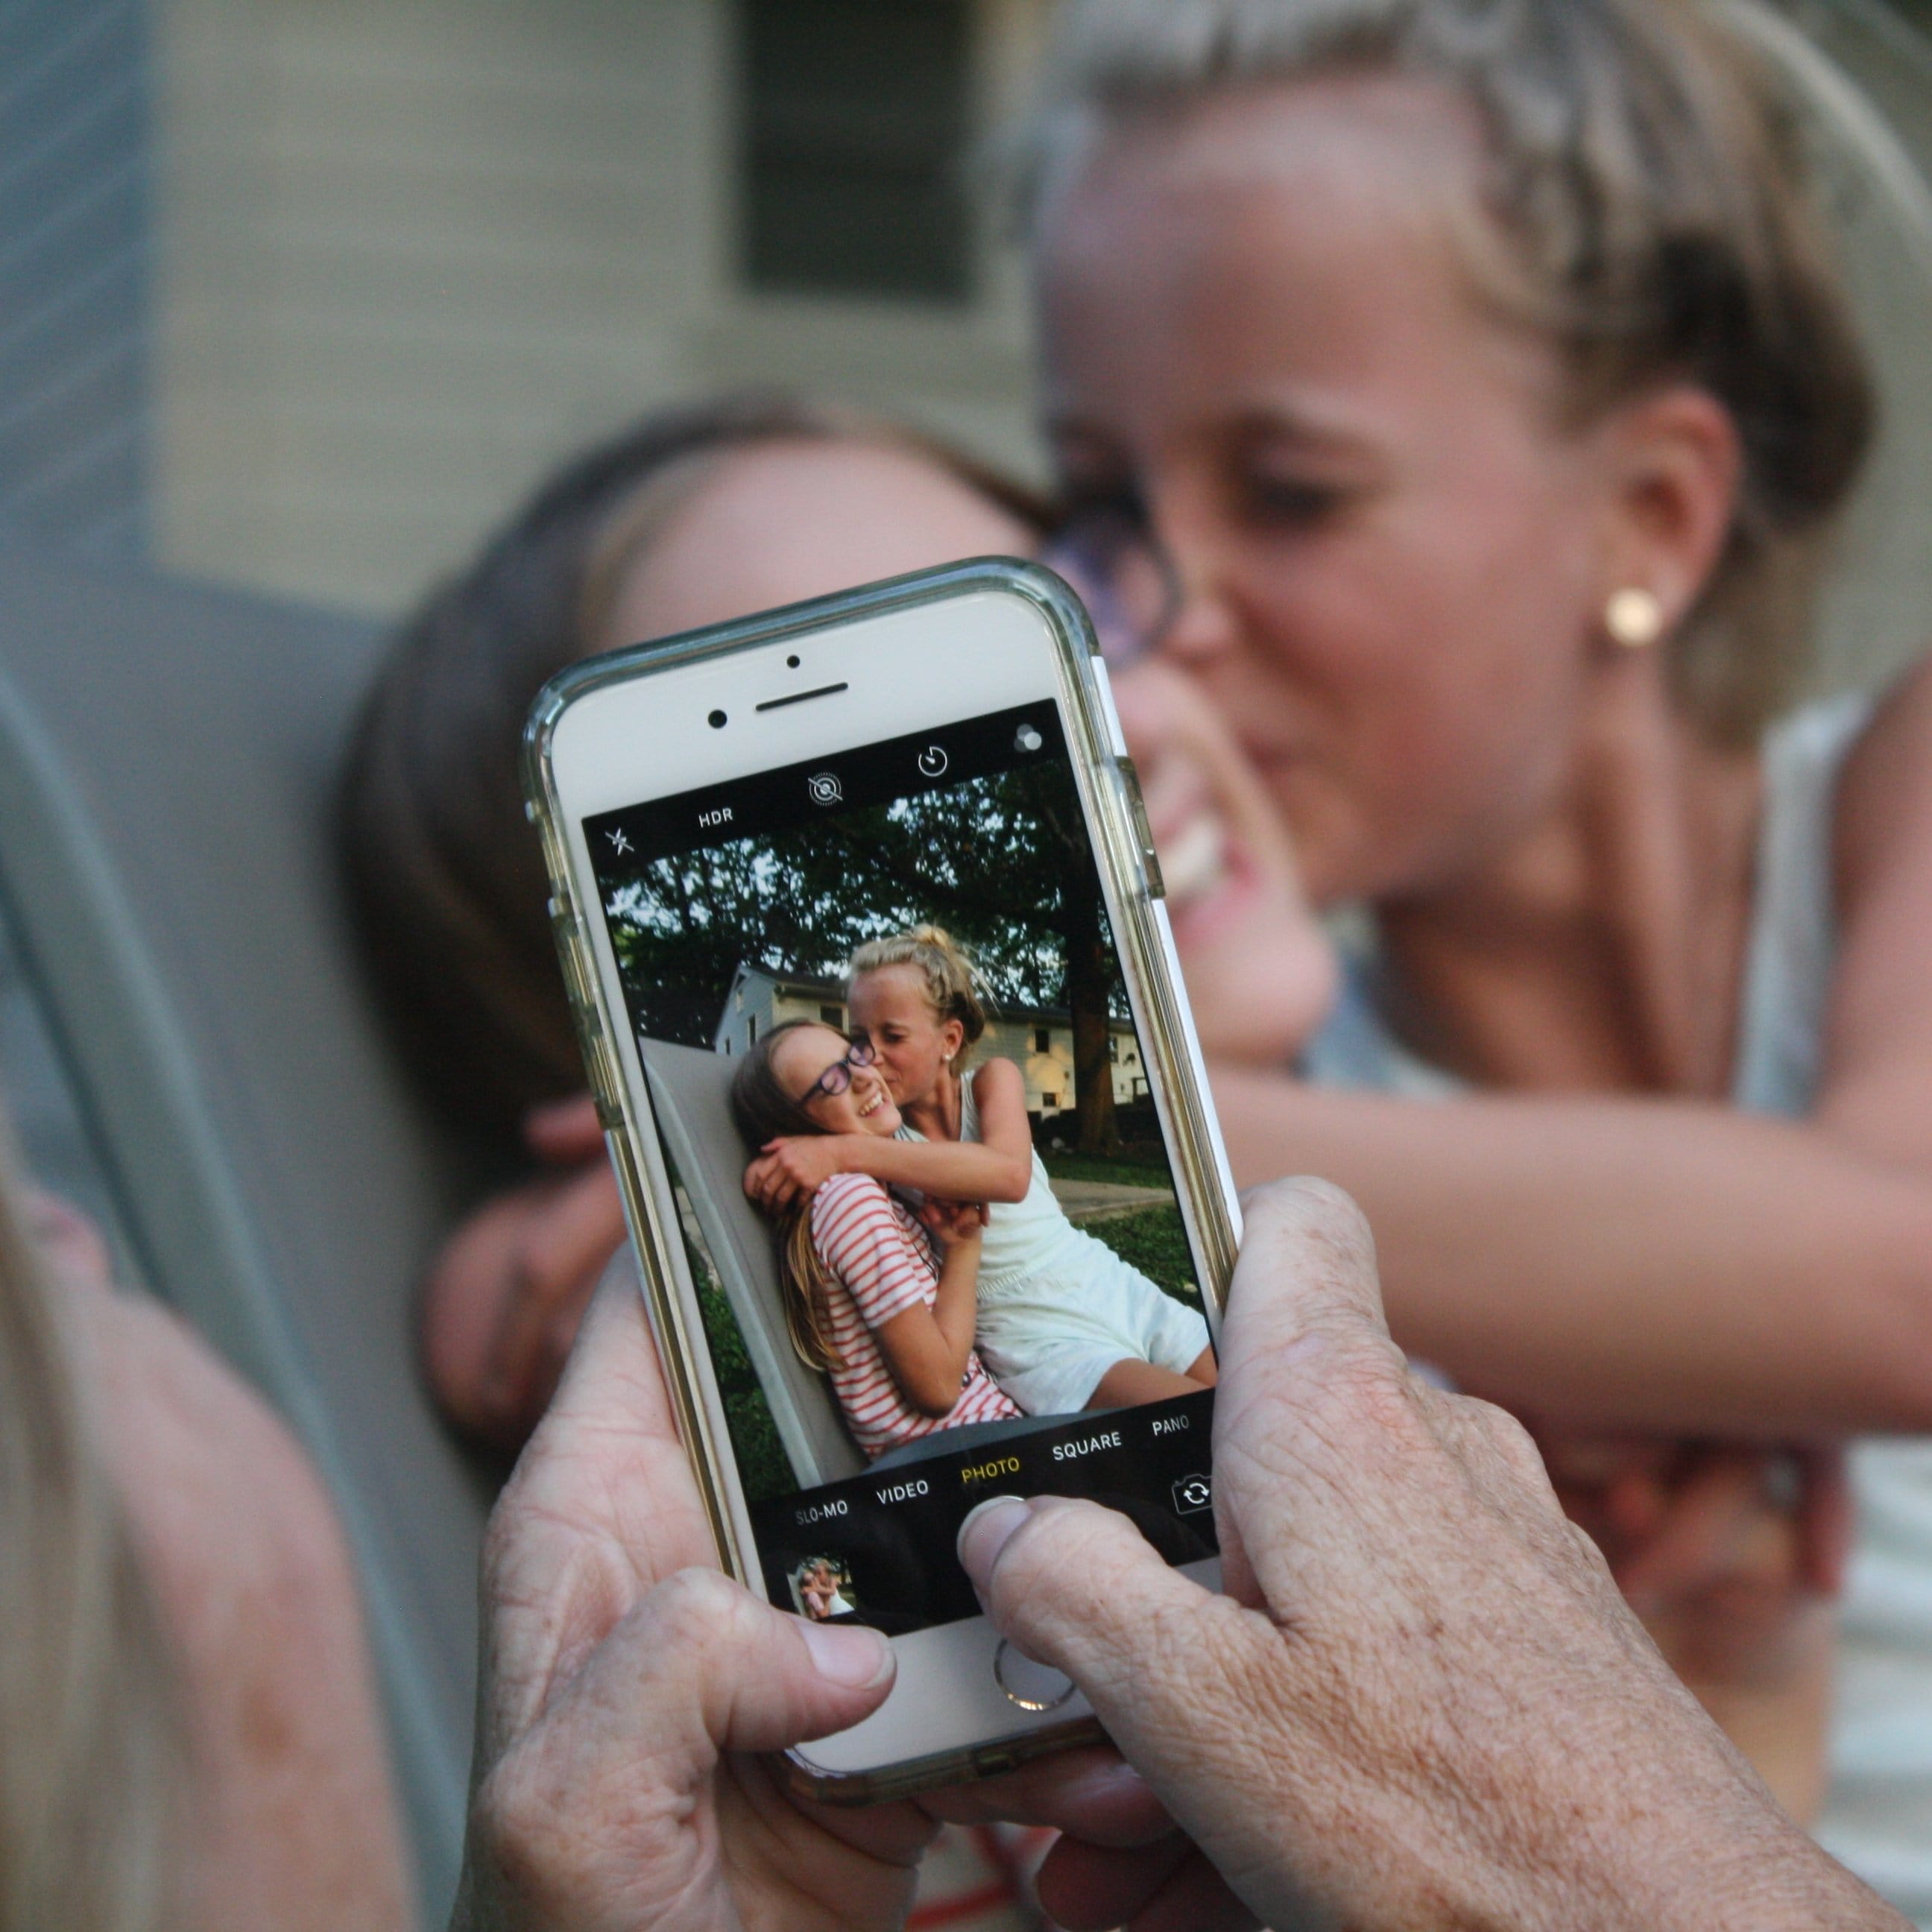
[738,0,972,301]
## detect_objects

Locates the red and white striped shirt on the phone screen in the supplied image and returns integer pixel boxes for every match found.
[812,1175,1020,1455]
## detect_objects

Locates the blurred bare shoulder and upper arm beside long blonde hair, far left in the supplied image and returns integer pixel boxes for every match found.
[66,1283,408,1932]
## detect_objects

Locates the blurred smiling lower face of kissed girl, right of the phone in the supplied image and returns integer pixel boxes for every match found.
[1113,660,1339,1067]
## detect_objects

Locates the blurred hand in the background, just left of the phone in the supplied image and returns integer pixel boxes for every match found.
[423,1093,624,1449]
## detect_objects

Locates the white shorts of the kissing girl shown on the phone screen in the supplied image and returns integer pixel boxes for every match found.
[973,1229,1208,1416]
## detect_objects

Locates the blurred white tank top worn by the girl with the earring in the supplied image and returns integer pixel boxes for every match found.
[1302,694,1932,1932]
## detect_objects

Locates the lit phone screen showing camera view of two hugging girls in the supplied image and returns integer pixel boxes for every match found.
[584,699,1215,1635]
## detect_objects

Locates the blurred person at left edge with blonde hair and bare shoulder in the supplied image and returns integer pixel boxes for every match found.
[0,1128,415,1932]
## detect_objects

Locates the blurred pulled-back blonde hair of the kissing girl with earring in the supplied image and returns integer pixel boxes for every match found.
[1024,0,1876,744]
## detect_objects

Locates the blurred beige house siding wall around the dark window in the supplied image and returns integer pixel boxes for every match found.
[154,0,1044,613]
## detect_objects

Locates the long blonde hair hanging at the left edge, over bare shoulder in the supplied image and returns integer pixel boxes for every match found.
[0,1123,183,1932]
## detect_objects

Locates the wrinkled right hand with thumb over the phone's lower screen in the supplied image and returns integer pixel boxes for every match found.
[960,1182,1903,1932]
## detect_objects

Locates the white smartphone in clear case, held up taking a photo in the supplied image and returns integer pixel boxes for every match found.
[525,558,1238,1802]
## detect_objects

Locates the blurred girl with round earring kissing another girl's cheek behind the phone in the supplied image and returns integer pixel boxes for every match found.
[1032,0,1932,1885]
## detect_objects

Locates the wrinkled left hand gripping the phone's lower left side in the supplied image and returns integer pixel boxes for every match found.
[454,1267,933,1932]
